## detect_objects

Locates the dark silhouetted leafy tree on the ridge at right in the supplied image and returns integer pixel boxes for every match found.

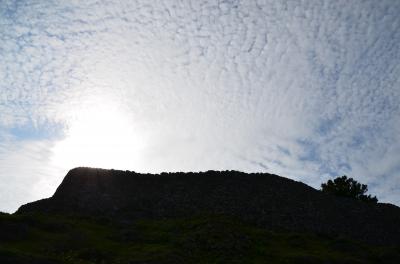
[321,175,378,203]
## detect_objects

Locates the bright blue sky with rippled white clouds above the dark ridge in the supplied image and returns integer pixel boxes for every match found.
[0,0,400,212]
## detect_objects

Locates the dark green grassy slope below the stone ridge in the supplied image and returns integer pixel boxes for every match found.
[0,211,400,264]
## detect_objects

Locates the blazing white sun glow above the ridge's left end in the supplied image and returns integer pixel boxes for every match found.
[53,96,144,170]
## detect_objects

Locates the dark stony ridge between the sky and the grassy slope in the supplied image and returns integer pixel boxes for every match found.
[16,168,400,245]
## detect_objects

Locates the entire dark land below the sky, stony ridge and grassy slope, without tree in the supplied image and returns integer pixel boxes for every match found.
[0,168,400,263]
